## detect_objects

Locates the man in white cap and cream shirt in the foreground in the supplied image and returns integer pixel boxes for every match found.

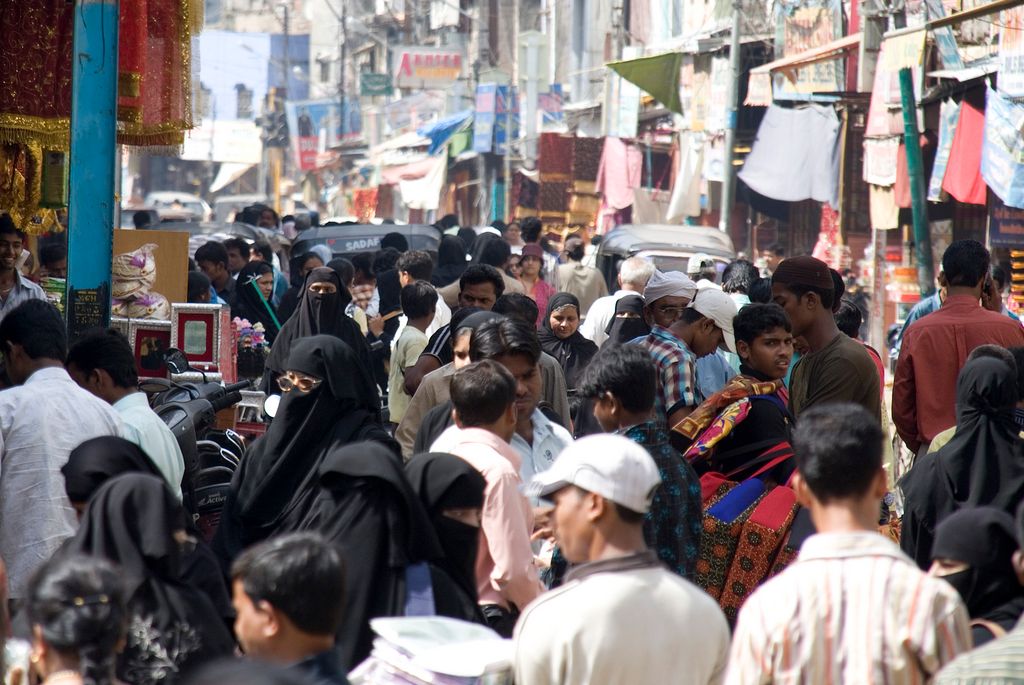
[514,435,729,685]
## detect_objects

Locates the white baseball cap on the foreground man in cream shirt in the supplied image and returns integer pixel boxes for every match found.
[526,434,662,514]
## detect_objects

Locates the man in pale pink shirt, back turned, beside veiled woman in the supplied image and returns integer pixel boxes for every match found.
[436,360,544,637]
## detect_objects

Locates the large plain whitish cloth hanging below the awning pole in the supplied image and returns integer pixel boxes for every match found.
[739,104,841,206]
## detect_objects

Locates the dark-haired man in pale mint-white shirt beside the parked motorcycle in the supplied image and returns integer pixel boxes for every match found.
[67,331,185,500]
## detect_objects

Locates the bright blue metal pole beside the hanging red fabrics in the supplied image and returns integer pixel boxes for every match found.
[68,0,118,339]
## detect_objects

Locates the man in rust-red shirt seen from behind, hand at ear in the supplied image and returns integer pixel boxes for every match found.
[893,241,1024,454]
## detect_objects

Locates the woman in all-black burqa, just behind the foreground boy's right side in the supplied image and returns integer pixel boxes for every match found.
[297,442,443,669]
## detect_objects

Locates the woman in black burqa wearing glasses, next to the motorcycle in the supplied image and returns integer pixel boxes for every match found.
[213,335,399,573]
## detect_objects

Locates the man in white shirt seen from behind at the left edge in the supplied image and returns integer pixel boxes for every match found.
[0,300,122,600]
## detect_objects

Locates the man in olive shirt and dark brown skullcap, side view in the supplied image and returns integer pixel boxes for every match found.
[771,256,882,423]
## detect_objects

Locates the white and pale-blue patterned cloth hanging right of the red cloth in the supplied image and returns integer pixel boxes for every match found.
[981,88,1024,209]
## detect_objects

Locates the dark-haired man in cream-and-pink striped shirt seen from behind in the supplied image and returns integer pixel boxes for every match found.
[726,403,971,685]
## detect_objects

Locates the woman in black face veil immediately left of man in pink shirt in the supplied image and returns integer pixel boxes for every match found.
[406,453,487,625]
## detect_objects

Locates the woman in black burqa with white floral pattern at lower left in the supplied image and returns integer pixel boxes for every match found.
[62,473,234,685]
